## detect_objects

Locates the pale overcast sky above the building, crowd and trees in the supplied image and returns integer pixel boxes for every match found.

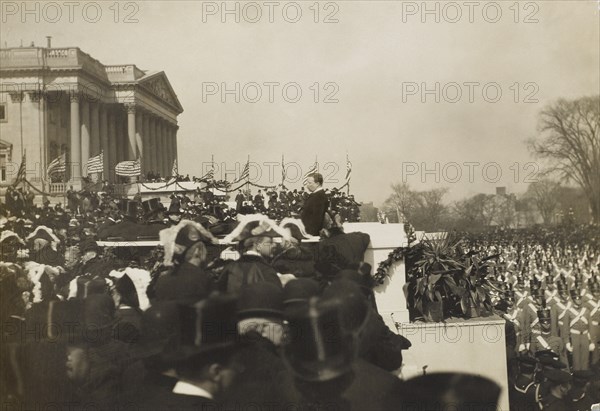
[0,1,600,204]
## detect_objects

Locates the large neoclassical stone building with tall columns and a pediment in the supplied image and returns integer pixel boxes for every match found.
[0,47,183,190]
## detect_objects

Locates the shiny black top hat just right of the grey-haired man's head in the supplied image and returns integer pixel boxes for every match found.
[283,298,355,382]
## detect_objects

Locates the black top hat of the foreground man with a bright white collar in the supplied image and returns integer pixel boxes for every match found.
[164,294,238,364]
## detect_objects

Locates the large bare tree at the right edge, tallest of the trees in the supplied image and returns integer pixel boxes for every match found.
[529,96,600,223]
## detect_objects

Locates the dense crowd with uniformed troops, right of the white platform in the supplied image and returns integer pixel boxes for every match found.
[465,224,600,410]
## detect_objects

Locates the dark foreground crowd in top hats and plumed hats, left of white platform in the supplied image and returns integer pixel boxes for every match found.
[0,183,500,410]
